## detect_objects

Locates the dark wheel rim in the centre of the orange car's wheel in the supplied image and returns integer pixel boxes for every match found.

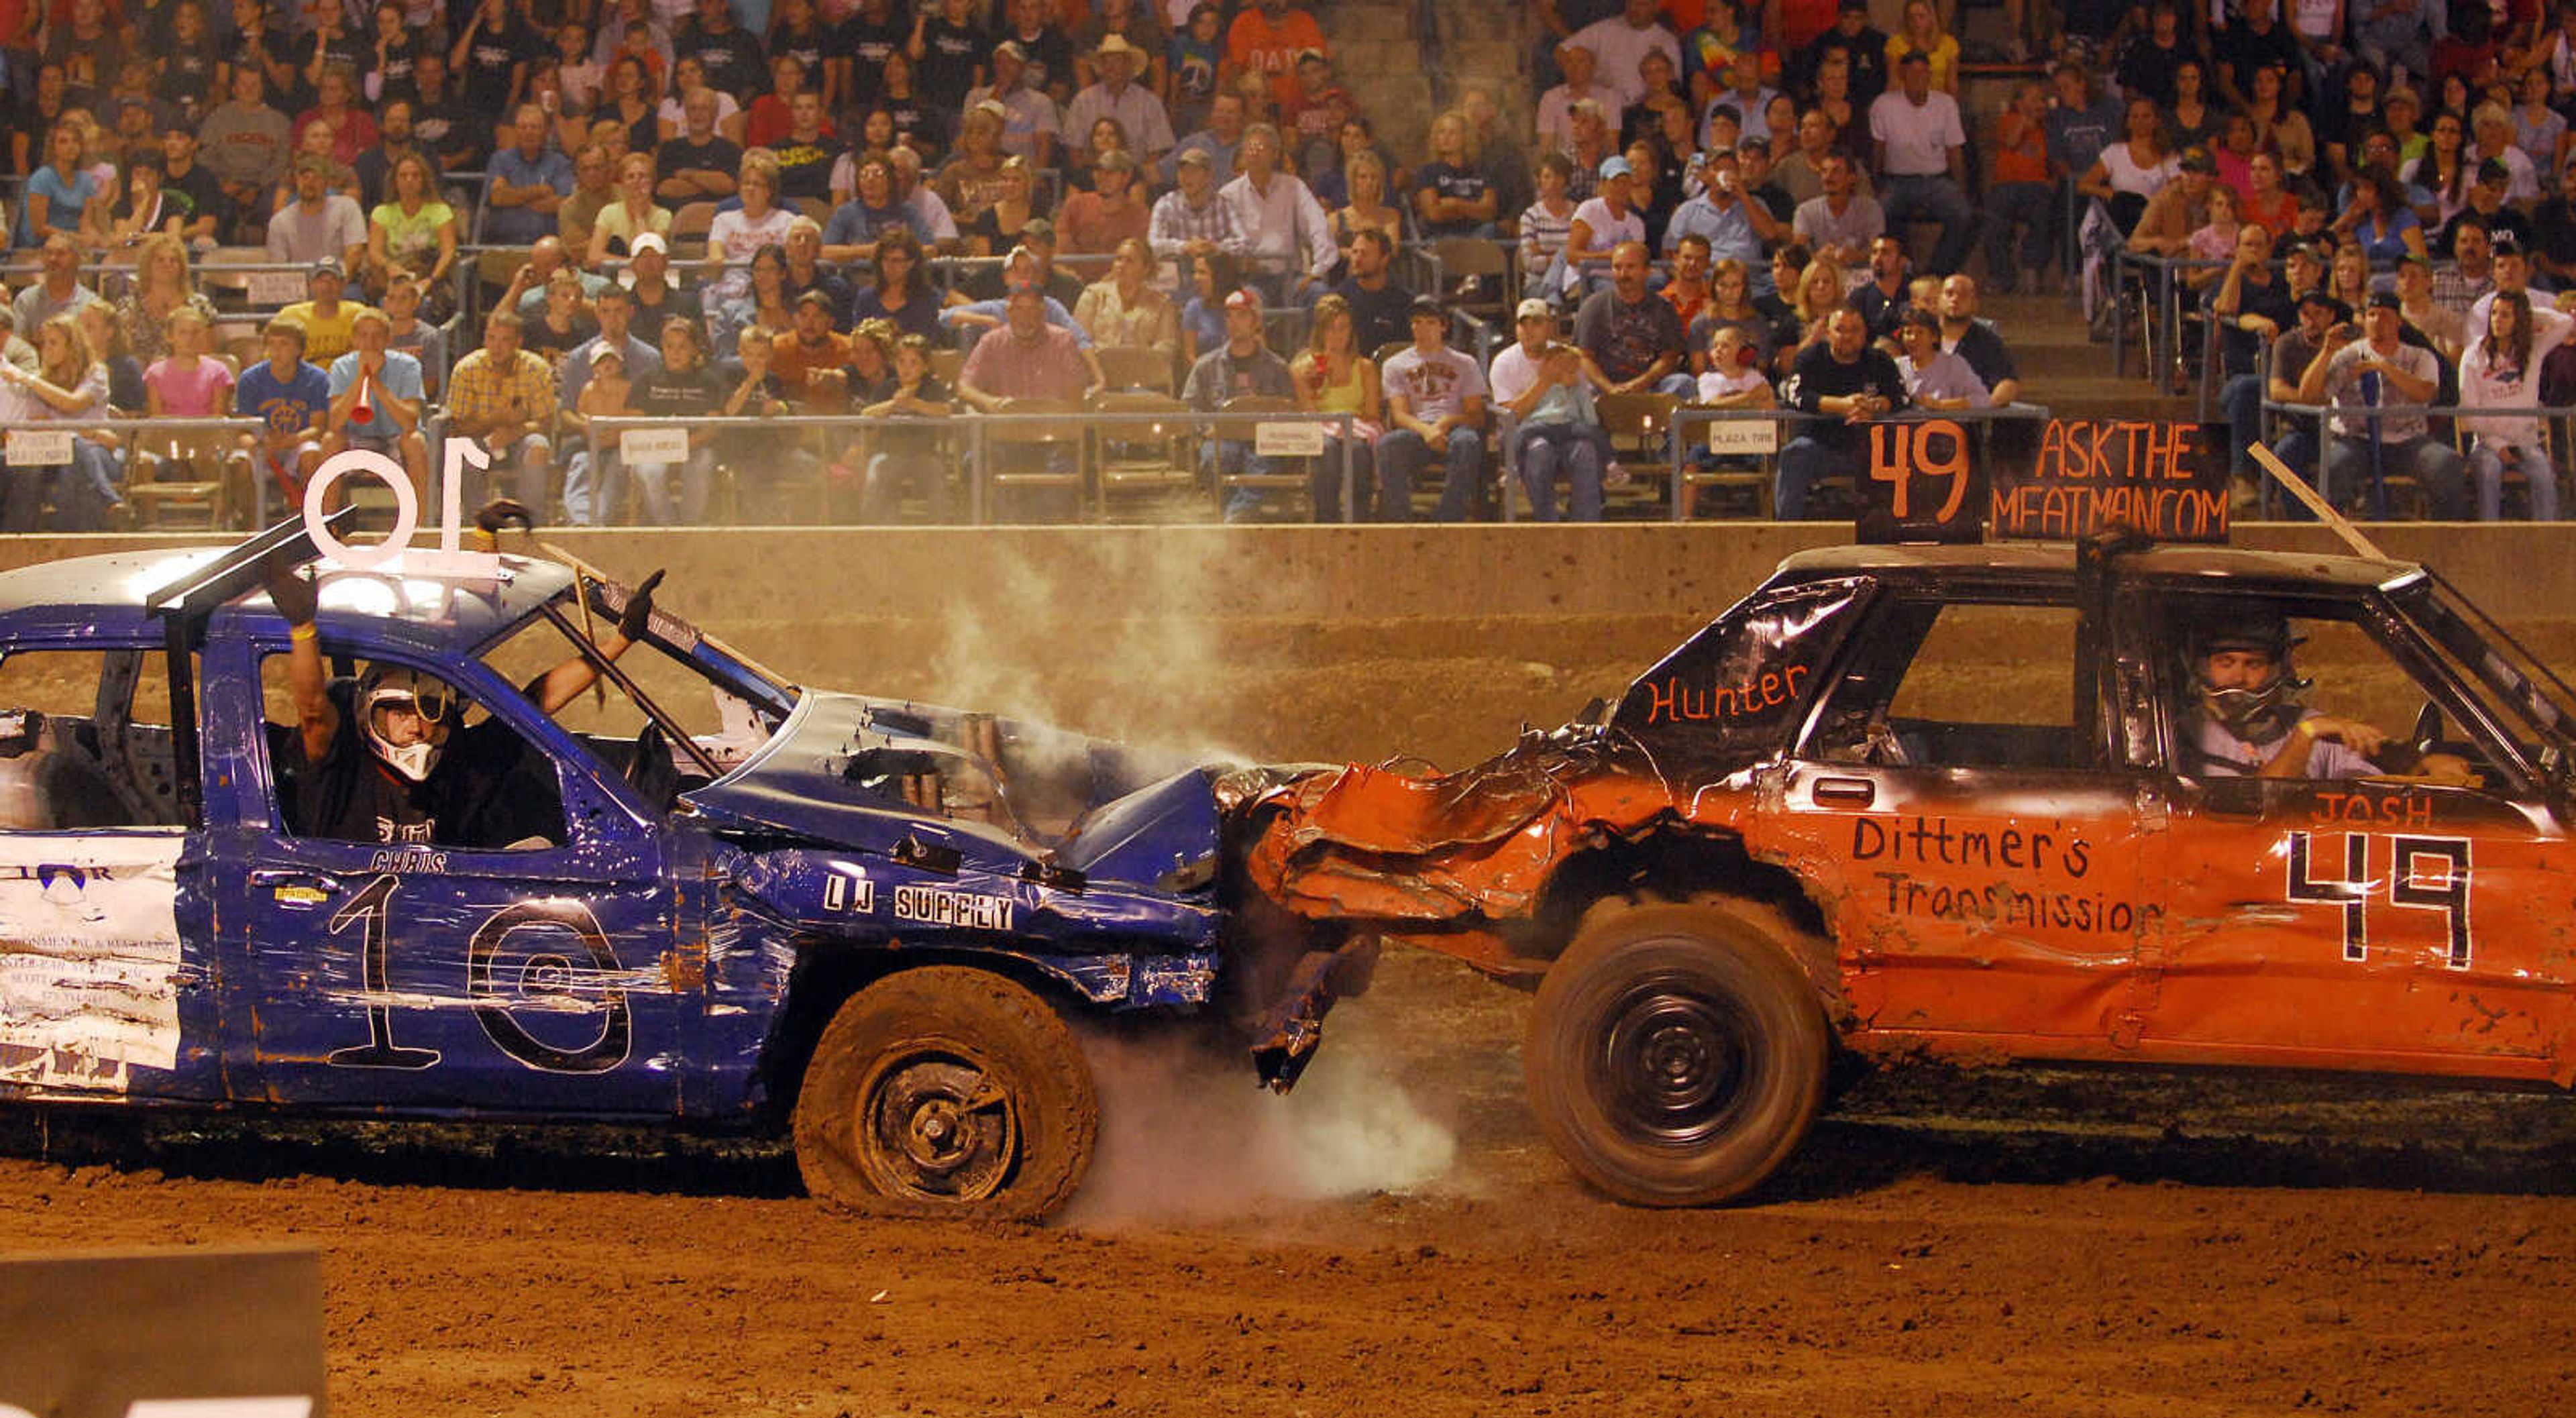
[1595,973,1760,1148]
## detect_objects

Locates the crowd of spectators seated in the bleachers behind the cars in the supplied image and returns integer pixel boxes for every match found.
[0,0,2576,530]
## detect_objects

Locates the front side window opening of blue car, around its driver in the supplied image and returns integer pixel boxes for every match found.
[260,651,567,852]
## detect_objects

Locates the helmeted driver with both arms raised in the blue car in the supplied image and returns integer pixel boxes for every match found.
[268,499,662,849]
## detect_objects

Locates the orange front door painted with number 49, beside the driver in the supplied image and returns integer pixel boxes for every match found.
[2123,579,2576,1076]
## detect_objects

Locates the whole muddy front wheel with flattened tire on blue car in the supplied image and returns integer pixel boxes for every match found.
[796,965,1100,1220]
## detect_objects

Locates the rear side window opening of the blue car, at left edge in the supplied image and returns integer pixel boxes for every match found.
[0,649,180,831]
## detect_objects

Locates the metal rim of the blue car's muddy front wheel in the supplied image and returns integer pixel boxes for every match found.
[858,1050,1020,1202]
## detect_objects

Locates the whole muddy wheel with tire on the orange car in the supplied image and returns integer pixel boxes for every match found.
[1522,901,1831,1207]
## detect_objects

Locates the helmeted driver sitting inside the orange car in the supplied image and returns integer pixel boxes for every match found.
[2184,607,2473,782]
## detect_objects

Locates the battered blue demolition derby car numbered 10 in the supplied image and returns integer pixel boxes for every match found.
[0,525,1347,1217]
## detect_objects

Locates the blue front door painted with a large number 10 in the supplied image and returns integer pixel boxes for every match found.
[209,643,703,1114]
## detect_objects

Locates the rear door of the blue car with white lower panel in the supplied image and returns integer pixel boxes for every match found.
[0,631,221,1101]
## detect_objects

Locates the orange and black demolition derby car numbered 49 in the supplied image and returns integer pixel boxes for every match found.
[1247,543,2576,1205]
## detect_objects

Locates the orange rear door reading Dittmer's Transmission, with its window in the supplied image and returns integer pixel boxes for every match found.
[1762,584,2151,1052]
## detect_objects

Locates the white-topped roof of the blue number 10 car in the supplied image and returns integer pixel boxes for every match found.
[0,545,572,654]
